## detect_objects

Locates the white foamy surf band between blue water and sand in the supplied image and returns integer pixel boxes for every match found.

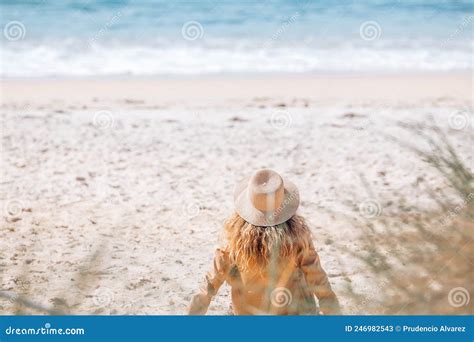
[1,40,473,78]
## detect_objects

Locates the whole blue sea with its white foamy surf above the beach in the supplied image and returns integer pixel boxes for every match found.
[0,0,474,78]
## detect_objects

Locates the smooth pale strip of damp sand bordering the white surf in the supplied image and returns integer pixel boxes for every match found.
[1,73,472,109]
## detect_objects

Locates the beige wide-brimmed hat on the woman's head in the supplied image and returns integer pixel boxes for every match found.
[234,169,300,227]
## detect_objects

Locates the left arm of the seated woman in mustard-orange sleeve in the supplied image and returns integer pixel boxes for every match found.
[189,248,229,315]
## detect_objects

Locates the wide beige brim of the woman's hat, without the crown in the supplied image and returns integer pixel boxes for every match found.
[234,177,300,227]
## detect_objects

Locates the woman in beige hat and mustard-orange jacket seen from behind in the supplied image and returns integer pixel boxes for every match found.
[189,169,340,315]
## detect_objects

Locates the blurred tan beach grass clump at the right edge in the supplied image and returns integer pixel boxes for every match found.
[344,120,474,314]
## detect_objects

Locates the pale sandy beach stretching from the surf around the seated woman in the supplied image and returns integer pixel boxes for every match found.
[0,73,473,315]
